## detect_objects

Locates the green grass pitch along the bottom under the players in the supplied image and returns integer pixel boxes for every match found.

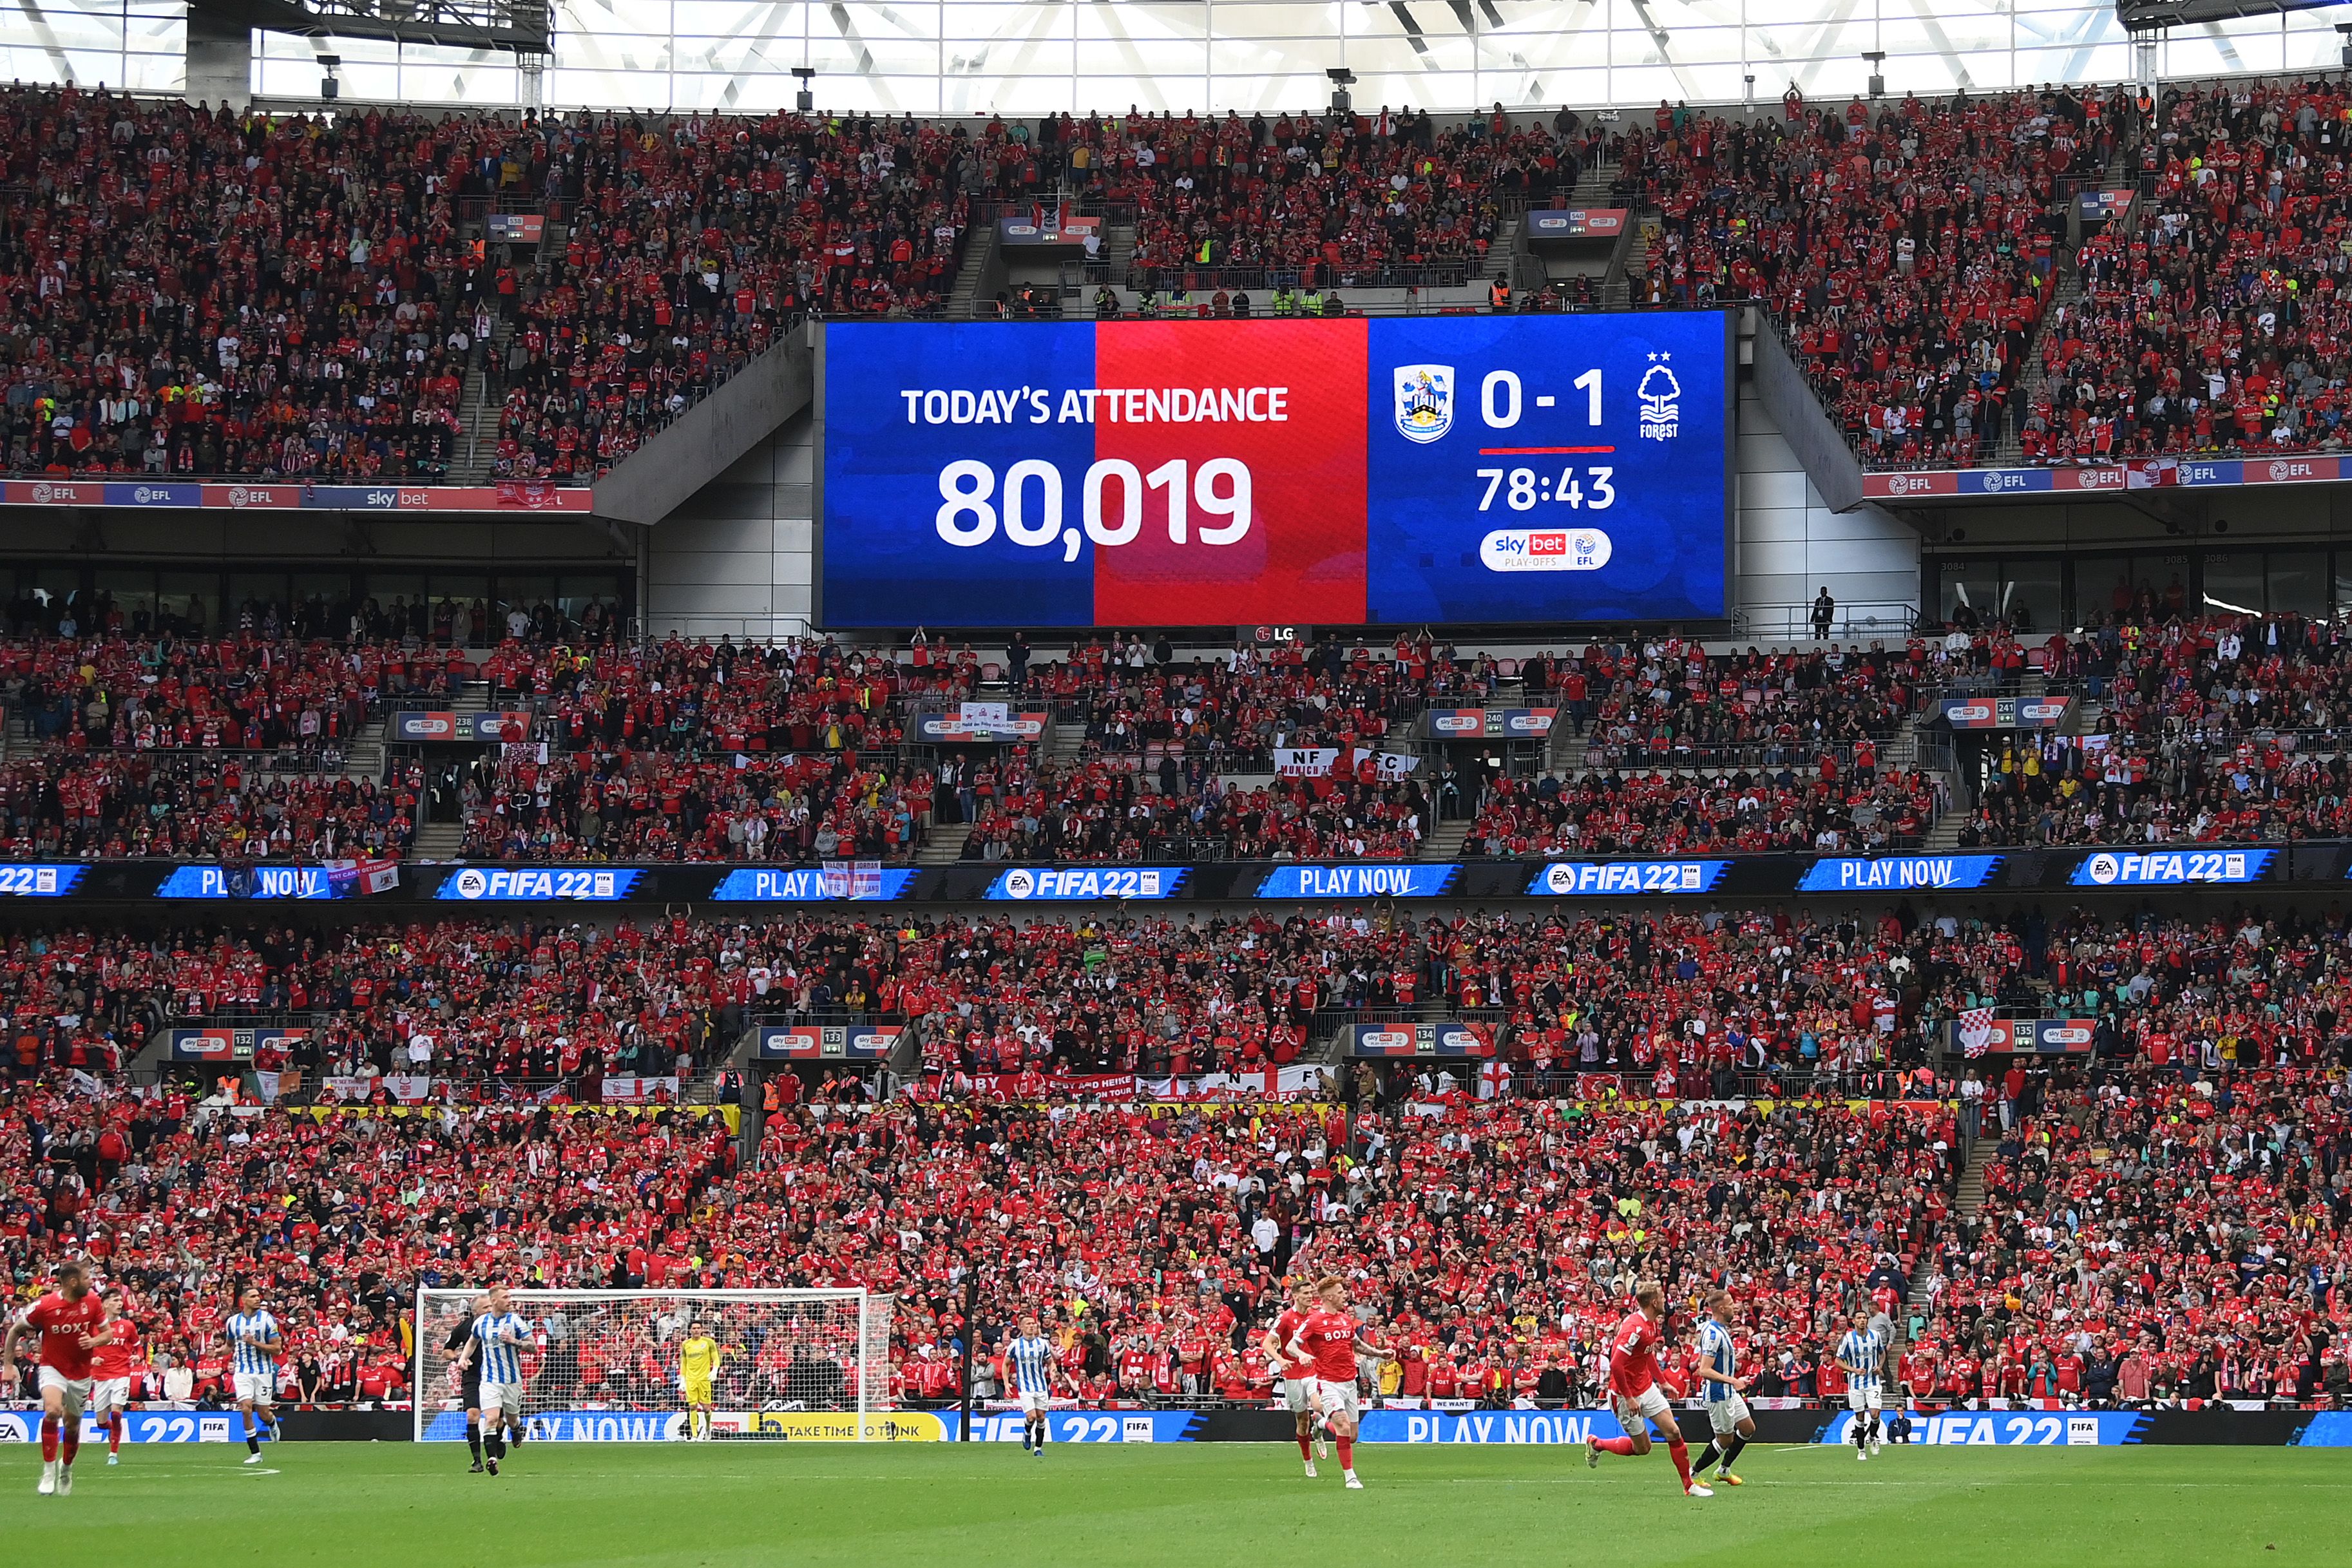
[0,1444,2352,1568]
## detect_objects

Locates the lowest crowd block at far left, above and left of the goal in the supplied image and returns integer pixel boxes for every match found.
[0,1082,734,1408]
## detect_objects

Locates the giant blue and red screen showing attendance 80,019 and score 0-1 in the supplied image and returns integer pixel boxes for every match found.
[819,312,1731,627]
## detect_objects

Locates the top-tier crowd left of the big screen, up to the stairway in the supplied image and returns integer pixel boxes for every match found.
[0,84,983,482]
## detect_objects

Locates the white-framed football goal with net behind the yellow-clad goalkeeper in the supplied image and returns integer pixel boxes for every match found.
[416,1290,899,1444]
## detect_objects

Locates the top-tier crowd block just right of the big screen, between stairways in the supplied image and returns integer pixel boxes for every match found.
[1616,90,2098,468]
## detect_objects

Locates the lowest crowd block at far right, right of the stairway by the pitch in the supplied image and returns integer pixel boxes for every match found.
[1900,1055,2352,1408]
